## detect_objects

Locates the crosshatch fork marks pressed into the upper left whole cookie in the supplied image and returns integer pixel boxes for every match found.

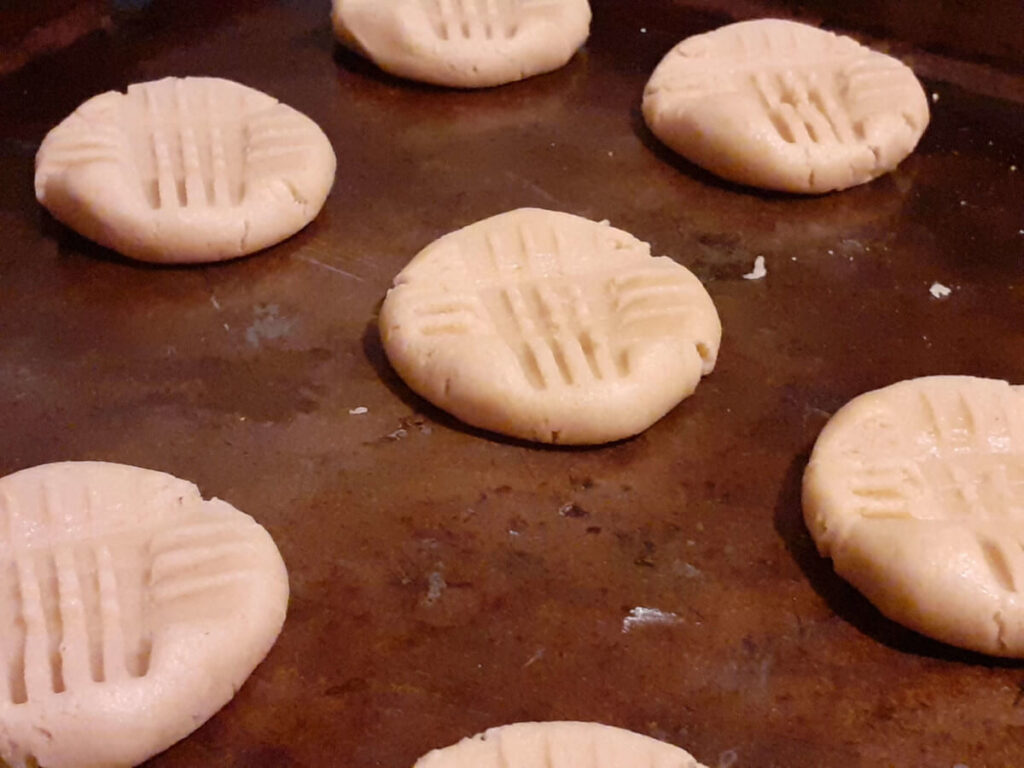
[37,78,323,211]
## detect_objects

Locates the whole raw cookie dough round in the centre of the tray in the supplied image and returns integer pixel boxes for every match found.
[380,208,722,443]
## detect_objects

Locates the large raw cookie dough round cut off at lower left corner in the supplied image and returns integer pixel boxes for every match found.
[0,462,288,768]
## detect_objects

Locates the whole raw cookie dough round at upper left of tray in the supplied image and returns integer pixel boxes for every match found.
[36,78,335,262]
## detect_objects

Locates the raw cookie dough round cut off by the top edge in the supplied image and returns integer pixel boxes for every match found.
[332,0,590,88]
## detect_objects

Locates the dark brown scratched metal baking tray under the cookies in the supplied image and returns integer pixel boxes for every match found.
[0,0,1024,768]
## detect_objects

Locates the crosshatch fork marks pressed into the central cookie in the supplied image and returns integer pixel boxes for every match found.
[403,218,697,390]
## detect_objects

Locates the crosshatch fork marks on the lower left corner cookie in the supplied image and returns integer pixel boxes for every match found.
[0,484,268,705]
